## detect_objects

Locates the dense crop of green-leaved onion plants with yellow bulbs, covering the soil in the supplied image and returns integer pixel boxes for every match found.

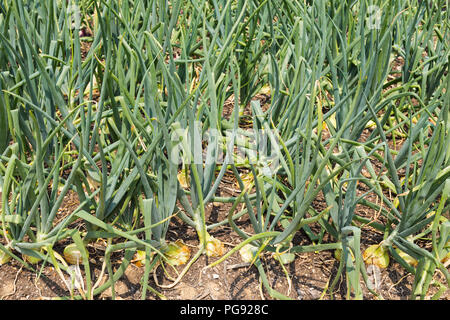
[0,0,450,299]
